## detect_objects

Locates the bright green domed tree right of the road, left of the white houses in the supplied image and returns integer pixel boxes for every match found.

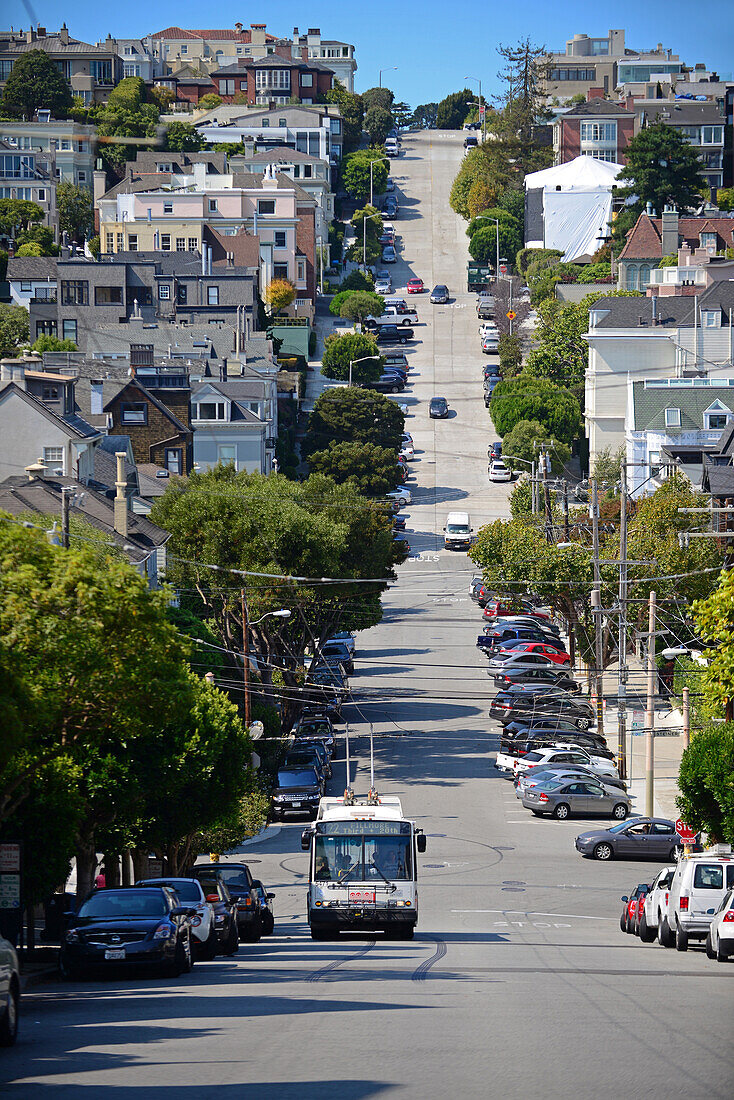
[490,374,581,443]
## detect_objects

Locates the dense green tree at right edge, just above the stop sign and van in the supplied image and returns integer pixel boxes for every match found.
[676,722,734,844]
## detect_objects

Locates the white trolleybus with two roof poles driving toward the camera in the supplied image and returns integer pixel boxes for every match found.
[302,792,426,939]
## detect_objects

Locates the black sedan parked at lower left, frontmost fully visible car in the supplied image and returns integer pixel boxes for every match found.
[59,887,196,980]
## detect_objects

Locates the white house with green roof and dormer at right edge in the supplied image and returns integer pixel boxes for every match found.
[625,376,734,496]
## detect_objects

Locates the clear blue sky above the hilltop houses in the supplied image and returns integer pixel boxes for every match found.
[7,0,734,107]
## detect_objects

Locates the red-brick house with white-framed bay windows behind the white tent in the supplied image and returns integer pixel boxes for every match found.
[552,98,635,164]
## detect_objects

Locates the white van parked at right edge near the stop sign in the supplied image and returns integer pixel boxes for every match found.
[659,845,734,952]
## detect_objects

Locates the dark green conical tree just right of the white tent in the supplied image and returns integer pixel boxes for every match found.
[620,122,705,216]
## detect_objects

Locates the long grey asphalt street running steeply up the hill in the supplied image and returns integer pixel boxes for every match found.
[0,134,734,1100]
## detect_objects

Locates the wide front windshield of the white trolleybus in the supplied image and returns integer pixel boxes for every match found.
[314,834,413,882]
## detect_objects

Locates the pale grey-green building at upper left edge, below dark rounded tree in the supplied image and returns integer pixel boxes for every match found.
[0,110,97,190]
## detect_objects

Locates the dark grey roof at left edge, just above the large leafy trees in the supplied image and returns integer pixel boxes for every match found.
[0,476,171,563]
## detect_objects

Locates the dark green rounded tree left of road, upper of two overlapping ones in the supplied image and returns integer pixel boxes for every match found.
[304,386,405,455]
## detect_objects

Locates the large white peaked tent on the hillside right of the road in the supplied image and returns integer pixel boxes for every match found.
[525,156,624,262]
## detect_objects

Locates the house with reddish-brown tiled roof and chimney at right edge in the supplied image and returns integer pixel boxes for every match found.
[617,207,734,290]
